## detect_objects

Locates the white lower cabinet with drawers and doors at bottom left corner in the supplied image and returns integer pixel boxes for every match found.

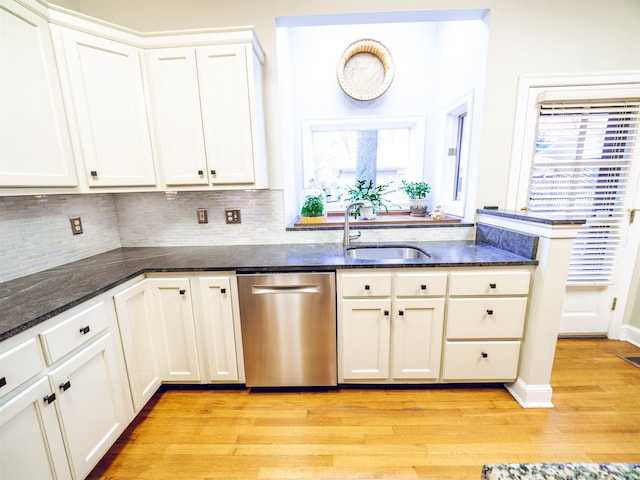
[0,294,134,480]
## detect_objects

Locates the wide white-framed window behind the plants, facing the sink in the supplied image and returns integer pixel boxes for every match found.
[303,118,424,211]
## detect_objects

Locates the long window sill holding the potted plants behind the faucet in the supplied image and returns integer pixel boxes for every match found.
[287,211,473,231]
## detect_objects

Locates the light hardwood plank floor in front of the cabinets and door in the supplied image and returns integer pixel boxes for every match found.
[89,339,640,480]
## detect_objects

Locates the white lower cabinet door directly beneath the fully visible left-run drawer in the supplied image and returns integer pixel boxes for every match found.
[50,331,128,478]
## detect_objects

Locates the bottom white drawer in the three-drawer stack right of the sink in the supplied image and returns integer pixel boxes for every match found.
[442,341,520,381]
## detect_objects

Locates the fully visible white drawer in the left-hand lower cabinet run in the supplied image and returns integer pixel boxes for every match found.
[40,302,109,365]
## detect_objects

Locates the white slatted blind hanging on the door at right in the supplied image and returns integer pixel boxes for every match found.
[527,98,640,285]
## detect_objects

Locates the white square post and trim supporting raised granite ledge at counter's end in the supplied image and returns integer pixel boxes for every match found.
[478,213,584,408]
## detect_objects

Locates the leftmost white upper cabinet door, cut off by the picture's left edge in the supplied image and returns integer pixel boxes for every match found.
[0,0,77,187]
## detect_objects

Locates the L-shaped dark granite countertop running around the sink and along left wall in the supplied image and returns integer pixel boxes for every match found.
[0,241,537,341]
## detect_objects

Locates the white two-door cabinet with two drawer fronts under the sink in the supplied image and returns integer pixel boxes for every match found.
[337,271,446,383]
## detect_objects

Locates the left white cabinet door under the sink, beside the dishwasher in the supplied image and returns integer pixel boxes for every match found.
[339,299,391,381]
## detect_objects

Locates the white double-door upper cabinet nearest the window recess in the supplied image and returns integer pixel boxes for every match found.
[146,38,267,188]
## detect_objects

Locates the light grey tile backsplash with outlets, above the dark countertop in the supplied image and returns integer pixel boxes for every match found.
[0,190,474,282]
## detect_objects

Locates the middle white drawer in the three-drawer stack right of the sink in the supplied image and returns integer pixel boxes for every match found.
[447,297,527,339]
